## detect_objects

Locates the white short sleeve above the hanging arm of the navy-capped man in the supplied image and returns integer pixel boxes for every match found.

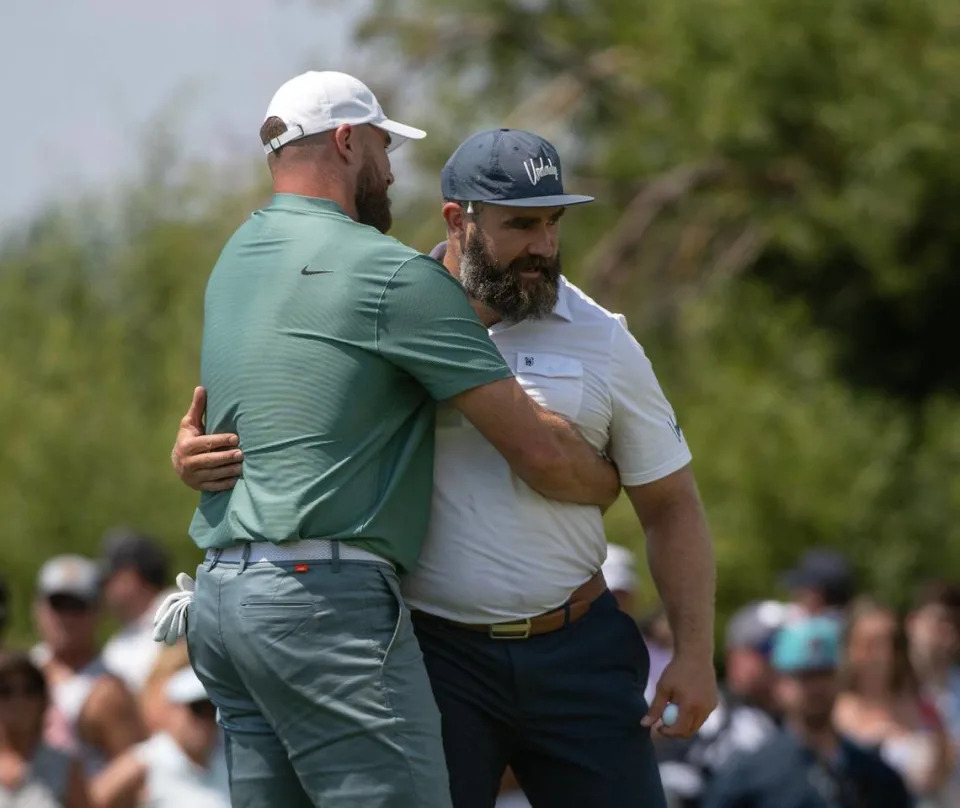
[607,317,691,485]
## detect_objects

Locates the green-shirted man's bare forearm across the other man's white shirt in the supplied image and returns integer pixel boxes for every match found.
[451,379,620,508]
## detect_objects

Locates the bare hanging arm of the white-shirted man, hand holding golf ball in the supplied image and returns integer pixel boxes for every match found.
[624,466,717,737]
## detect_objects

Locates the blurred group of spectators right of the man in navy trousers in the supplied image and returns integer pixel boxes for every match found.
[498,546,960,808]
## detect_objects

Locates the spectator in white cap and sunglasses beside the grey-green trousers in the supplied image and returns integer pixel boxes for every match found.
[95,667,230,808]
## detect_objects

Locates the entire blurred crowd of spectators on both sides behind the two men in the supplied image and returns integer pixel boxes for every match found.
[0,531,960,808]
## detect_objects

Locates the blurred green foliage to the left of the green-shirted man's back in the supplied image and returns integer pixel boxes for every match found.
[0,170,268,636]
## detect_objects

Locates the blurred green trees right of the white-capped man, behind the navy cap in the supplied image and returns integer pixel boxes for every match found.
[354,0,960,624]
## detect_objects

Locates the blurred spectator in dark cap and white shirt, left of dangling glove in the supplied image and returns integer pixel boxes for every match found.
[100,530,176,694]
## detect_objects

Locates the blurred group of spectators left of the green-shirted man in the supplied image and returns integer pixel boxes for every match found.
[0,531,230,808]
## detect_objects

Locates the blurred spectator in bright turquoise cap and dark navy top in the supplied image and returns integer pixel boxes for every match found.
[703,617,913,808]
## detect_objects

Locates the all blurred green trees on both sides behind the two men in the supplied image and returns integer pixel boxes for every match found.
[0,0,960,634]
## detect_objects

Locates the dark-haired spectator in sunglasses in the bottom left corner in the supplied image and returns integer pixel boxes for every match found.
[0,651,89,808]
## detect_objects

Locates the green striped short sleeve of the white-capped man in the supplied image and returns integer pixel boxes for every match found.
[377,256,512,401]
